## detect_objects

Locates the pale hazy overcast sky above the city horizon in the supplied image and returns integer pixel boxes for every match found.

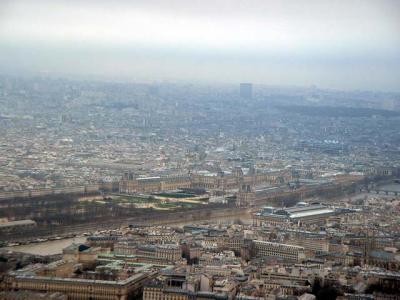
[0,0,400,91]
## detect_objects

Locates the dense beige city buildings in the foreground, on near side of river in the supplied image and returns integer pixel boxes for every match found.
[0,206,400,300]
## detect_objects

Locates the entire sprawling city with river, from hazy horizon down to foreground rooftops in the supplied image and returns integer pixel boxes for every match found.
[0,76,400,300]
